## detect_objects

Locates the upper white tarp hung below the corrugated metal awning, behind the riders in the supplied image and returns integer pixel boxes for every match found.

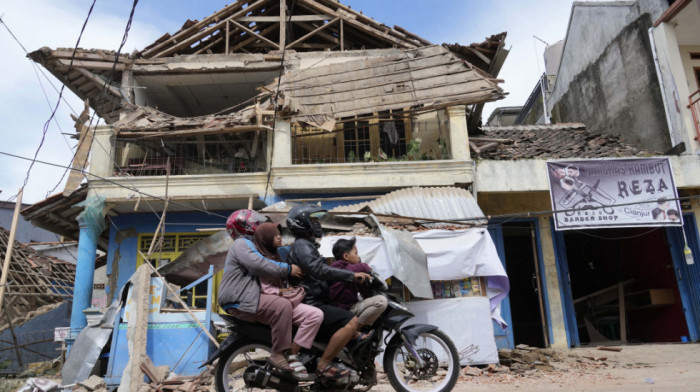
[319,228,510,326]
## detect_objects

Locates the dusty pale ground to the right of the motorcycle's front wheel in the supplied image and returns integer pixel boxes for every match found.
[374,344,700,392]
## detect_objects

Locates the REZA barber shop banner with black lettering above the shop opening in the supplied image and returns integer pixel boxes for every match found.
[547,158,683,230]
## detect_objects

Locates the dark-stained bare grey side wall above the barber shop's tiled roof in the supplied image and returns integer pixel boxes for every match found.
[548,13,672,152]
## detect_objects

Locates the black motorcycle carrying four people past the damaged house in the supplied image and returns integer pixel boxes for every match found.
[205,276,460,392]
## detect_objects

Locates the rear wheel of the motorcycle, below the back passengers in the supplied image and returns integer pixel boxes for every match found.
[215,342,271,392]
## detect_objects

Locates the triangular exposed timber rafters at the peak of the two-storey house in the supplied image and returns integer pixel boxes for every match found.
[134,0,430,58]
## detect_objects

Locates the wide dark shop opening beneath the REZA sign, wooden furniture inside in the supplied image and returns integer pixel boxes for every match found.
[564,228,688,344]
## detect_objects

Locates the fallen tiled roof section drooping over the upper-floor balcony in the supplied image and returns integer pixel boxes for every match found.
[115,45,505,137]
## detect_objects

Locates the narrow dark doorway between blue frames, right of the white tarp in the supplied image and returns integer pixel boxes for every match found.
[502,222,547,347]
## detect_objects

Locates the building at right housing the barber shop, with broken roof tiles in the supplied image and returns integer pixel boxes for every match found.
[470,0,700,347]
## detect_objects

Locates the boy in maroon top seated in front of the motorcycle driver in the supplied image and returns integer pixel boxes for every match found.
[330,238,387,339]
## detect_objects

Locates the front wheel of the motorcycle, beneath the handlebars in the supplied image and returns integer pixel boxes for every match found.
[384,329,459,392]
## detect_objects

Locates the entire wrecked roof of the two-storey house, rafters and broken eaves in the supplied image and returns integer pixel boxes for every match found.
[29,0,508,128]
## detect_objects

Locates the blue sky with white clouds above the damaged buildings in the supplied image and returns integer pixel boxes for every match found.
[0,0,572,203]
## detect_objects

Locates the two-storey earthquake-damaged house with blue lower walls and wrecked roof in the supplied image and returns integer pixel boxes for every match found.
[24,0,508,383]
